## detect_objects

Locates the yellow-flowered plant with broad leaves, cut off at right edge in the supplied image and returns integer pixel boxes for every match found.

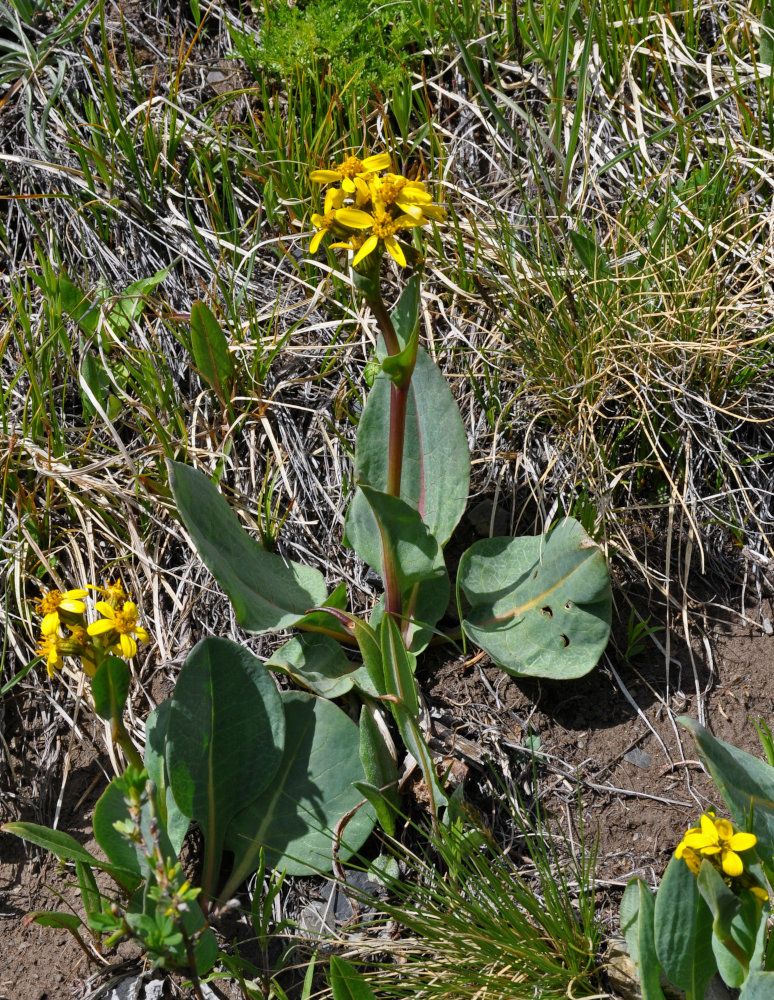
[621,719,774,1000]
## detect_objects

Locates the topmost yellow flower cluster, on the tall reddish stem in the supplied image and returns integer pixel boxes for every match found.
[309,153,445,267]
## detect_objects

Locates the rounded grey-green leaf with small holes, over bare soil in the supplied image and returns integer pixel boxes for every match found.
[458,518,610,679]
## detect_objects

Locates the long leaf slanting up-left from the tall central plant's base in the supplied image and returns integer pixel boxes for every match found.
[167,462,327,632]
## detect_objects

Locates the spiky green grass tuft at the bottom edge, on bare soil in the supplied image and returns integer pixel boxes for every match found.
[330,794,601,1000]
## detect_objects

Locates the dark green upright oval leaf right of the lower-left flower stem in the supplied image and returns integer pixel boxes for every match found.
[166,639,285,895]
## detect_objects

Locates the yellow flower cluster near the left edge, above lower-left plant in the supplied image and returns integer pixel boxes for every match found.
[36,580,148,677]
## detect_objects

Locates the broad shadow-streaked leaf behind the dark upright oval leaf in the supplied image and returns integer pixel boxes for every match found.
[225,691,375,895]
